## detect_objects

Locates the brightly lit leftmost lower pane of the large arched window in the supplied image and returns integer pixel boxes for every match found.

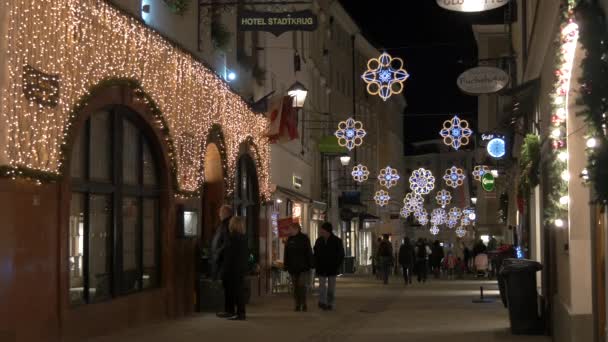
[69,193,85,304]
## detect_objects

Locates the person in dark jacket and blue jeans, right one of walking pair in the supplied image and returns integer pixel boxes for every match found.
[314,222,344,310]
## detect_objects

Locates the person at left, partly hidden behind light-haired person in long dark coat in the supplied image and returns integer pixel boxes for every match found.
[211,205,234,318]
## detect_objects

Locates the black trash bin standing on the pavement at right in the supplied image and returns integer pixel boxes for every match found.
[500,259,544,335]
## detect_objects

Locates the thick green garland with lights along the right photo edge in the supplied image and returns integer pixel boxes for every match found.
[576,1,608,203]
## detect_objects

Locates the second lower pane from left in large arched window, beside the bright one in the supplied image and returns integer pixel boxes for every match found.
[89,195,112,301]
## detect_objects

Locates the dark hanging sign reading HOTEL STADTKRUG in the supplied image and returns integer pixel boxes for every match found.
[237,10,319,37]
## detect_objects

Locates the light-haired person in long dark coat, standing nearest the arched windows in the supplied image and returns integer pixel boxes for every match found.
[222,216,249,321]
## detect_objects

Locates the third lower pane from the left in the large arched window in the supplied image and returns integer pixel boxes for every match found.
[122,197,140,292]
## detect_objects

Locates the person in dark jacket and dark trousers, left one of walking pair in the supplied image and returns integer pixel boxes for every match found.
[284,223,313,311]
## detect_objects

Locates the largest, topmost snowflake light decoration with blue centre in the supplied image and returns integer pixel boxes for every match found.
[361,52,410,101]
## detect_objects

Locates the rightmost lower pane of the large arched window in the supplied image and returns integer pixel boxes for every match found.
[143,198,159,288]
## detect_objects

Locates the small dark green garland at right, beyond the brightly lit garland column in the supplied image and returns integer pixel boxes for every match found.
[518,134,540,199]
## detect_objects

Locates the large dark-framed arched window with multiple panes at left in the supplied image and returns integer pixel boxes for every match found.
[69,106,160,304]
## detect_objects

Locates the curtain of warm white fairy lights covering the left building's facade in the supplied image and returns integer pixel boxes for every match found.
[2,0,270,199]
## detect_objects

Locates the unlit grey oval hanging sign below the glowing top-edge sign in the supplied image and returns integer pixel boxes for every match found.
[457,66,509,95]
